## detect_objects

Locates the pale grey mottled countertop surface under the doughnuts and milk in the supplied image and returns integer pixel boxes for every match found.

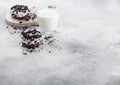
[0,0,120,85]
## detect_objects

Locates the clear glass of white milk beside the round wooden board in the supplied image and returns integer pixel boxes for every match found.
[37,6,59,32]
